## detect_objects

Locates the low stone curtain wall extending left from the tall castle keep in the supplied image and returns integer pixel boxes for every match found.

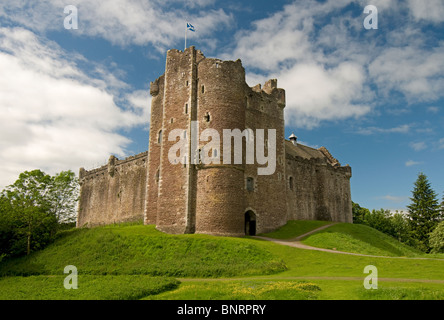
[77,152,147,227]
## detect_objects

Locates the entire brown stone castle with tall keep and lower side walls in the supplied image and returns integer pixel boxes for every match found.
[77,47,352,236]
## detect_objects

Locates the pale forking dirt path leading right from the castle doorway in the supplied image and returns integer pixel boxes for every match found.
[253,222,443,260]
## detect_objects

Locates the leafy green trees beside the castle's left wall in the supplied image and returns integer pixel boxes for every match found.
[0,170,78,257]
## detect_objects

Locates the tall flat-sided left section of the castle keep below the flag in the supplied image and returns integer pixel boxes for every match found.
[145,47,204,233]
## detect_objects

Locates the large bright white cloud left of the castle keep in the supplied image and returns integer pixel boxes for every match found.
[0,28,149,188]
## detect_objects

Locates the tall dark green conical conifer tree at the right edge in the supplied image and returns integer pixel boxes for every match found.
[407,173,442,251]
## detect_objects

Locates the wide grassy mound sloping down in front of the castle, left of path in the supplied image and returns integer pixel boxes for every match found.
[0,225,286,277]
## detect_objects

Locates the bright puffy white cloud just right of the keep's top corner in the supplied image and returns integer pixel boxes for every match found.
[278,62,370,127]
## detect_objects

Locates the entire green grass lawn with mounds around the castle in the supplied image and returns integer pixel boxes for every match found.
[0,221,444,300]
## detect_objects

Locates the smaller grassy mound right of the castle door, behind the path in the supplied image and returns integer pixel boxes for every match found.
[302,223,423,257]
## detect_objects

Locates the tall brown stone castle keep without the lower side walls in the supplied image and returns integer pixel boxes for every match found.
[145,47,286,236]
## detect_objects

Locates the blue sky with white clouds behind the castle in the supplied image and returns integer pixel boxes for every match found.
[0,0,444,211]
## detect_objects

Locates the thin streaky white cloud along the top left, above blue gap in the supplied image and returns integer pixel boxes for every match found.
[0,0,233,52]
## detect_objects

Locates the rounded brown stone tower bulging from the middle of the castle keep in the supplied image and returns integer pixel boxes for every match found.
[195,55,248,236]
